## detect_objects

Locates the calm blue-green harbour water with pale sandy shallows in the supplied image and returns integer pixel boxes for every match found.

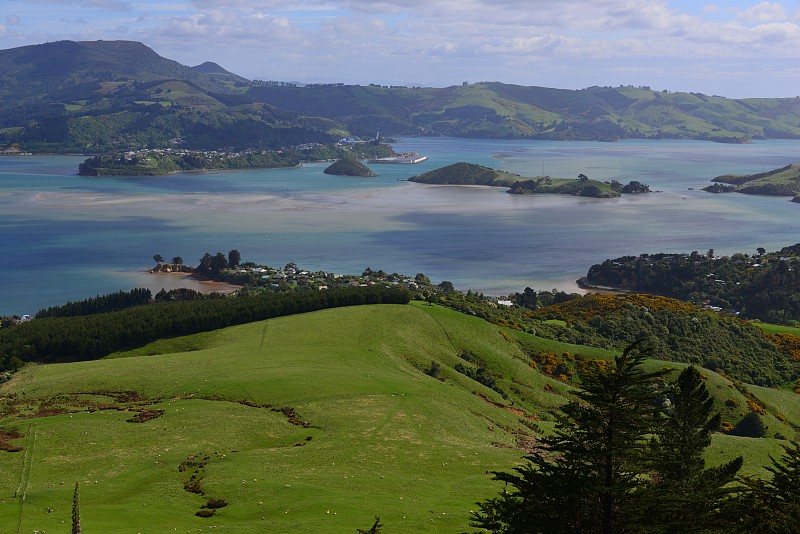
[0,138,800,315]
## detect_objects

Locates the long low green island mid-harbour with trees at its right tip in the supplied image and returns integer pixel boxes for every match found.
[408,162,650,198]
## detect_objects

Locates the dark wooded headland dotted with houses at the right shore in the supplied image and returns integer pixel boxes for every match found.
[586,244,800,325]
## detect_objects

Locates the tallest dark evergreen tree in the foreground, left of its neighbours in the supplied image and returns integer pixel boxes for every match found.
[472,342,661,534]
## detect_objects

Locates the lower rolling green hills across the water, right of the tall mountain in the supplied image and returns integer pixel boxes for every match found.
[248,82,800,143]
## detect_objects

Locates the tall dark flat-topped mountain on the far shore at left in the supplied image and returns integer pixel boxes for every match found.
[0,41,338,153]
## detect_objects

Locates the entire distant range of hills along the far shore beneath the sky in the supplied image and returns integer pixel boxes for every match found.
[0,41,800,153]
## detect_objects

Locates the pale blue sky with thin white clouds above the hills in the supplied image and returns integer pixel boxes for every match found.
[0,0,800,98]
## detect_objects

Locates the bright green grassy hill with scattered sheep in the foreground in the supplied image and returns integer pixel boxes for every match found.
[0,303,800,533]
